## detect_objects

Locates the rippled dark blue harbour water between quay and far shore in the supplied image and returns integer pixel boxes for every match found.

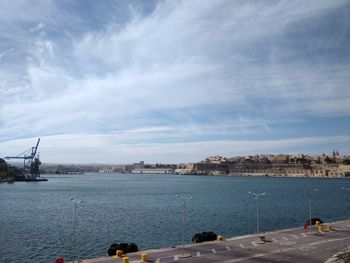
[0,174,350,263]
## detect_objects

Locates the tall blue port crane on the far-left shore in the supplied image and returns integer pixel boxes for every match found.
[5,138,41,179]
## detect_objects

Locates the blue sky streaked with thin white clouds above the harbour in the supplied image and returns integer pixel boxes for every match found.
[0,0,350,164]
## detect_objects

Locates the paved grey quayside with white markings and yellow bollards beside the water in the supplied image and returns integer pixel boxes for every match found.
[76,220,350,263]
